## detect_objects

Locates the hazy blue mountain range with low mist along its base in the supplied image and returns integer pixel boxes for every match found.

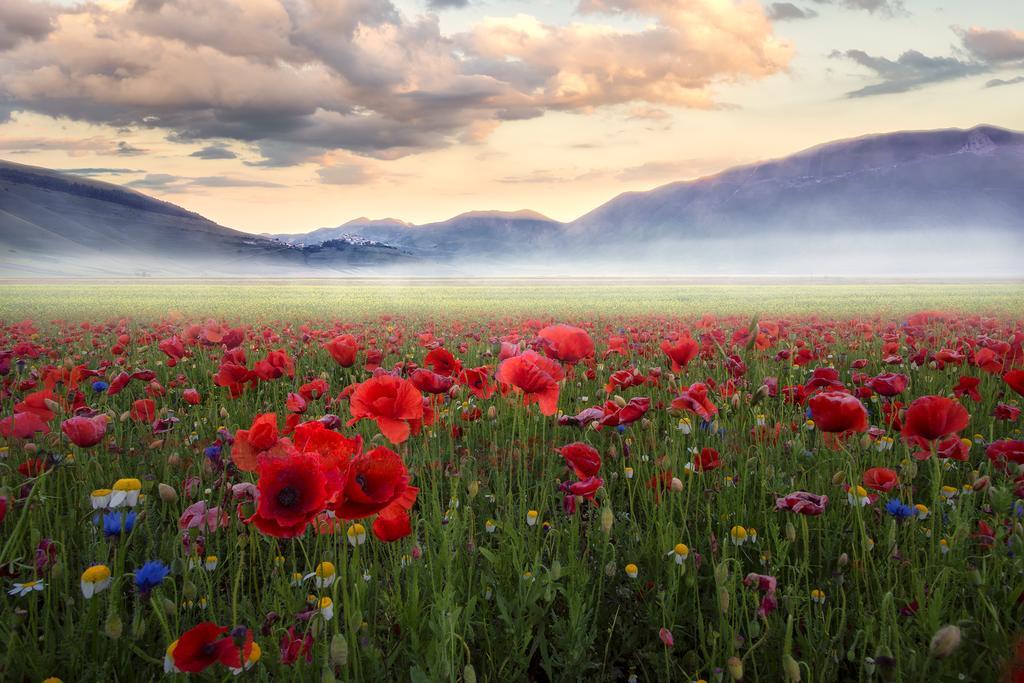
[0,126,1024,278]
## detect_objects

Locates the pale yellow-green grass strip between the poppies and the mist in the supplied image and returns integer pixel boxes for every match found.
[0,281,1024,321]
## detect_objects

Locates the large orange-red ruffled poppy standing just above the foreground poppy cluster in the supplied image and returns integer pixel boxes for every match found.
[348,375,423,443]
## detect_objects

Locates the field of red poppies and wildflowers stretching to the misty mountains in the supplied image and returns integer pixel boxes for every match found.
[0,285,1024,682]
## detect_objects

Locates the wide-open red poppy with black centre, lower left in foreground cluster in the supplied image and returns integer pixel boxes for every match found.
[247,453,333,538]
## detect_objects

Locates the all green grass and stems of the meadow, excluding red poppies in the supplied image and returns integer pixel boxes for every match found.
[0,284,1024,682]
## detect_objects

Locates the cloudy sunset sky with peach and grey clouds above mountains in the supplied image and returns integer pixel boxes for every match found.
[0,0,1024,232]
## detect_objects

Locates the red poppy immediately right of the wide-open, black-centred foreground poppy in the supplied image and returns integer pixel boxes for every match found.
[334,446,419,519]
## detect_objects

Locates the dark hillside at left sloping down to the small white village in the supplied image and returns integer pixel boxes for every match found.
[0,162,412,276]
